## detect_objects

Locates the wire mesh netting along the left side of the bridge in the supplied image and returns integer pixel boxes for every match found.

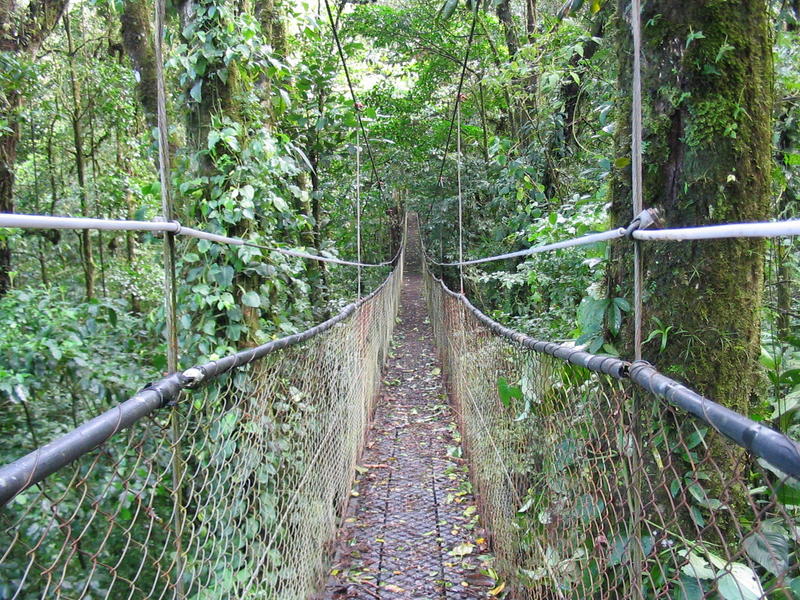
[0,259,402,600]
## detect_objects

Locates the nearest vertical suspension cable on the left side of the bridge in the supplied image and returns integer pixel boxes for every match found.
[153,0,186,600]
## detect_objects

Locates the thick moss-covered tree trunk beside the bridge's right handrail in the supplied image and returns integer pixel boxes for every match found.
[608,0,773,496]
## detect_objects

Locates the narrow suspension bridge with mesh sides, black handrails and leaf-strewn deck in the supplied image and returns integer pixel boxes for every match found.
[0,215,800,599]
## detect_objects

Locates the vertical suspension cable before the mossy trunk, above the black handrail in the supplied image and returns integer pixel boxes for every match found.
[631,0,643,360]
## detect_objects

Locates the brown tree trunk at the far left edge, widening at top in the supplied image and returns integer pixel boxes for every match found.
[0,0,68,296]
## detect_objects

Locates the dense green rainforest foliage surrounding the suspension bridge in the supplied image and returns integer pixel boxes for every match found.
[0,0,800,595]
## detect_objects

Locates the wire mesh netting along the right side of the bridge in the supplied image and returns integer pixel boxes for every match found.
[426,264,800,600]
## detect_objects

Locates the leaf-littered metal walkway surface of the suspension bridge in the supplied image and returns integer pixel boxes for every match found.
[324,273,494,600]
